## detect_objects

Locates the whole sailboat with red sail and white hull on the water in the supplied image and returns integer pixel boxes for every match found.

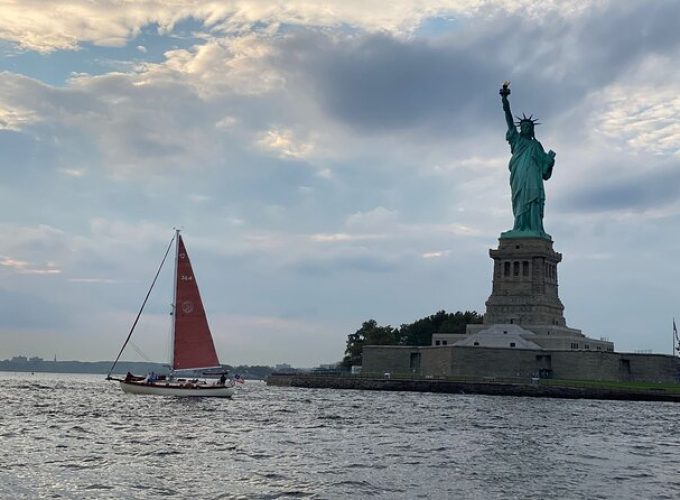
[106,229,235,398]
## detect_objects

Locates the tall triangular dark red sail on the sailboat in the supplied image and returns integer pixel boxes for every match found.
[172,235,220,370]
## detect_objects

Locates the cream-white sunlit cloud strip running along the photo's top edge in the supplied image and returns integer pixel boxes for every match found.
[0,0,606,52]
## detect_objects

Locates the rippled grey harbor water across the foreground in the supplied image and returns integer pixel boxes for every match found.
[0,373,680,499]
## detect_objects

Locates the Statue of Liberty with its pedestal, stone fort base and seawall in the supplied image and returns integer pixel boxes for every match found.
[270,82,680,394]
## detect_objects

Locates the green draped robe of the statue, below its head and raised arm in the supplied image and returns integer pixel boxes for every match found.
[505,127,555,236]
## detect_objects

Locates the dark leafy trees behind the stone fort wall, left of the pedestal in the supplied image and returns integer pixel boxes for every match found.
[341,311,484,369]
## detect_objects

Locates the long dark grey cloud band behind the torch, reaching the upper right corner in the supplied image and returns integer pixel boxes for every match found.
[274,2,680,138]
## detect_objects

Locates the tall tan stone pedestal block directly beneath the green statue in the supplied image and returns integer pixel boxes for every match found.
[484,237,566,329]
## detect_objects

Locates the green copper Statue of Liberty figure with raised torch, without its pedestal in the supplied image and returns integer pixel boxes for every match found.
[500,82,555,240]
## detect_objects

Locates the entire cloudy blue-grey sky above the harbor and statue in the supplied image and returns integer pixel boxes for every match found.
[0,0,680,367]
